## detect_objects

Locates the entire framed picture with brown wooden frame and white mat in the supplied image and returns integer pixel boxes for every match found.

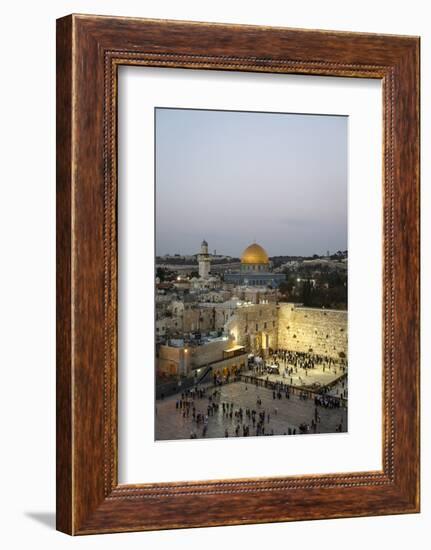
[57,15,419,535]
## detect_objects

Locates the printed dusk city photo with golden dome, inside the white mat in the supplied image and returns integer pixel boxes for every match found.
[154,107,348,444]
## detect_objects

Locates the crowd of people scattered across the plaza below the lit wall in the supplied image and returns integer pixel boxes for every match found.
[156,350,347,439]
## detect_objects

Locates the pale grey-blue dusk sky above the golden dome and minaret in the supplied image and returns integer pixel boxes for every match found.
[155,109,348,256]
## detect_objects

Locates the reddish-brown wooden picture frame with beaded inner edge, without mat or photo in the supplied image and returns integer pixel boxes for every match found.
[57,15,419,535]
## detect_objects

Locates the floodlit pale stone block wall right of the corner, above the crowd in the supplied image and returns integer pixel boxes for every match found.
[278,303,348,358]
